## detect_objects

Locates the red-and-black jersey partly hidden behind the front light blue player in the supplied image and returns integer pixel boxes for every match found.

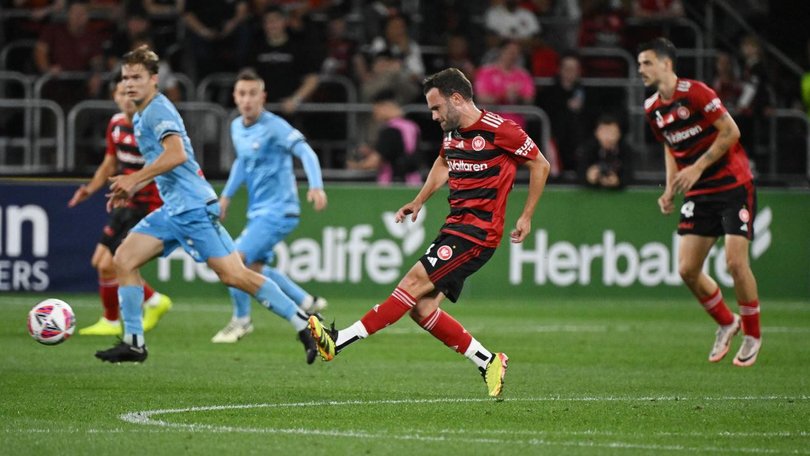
[105,112,163,212]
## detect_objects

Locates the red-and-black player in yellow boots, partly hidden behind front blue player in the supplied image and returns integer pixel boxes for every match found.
[68,75,171,336]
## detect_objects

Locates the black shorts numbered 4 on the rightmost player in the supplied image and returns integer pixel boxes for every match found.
[678,182,757,239]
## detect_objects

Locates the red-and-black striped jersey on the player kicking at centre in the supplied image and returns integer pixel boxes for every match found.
[439,111,540,247]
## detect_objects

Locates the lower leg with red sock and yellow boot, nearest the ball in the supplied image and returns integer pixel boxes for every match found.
[79,243,121,336]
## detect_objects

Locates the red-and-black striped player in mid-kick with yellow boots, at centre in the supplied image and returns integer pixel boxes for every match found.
[310,68,550,398]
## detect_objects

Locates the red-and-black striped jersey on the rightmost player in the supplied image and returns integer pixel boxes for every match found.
[644,79,753,196]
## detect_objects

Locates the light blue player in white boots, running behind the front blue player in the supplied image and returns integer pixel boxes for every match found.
[211,70,326,343]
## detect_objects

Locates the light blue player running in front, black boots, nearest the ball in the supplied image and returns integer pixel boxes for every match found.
[96,46,317,363]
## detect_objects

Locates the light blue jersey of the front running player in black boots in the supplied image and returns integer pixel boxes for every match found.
[133,93,217,215]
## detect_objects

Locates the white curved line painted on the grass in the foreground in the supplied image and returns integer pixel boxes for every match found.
[119,396,810,454]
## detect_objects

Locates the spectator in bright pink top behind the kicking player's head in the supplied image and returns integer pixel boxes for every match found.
[475,41,535,127]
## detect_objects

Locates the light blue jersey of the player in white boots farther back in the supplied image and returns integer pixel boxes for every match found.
[222,111,323,219]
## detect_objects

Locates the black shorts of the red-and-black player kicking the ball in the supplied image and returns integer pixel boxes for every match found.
[419,233,495,302]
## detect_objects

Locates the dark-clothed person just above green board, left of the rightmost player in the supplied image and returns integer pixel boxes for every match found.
[577,114,633,189]
